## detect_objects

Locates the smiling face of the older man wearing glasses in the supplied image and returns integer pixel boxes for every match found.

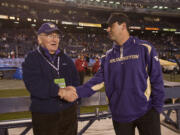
[38,32,60,54]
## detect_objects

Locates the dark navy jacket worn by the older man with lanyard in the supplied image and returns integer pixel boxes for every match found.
[22,49,79,113]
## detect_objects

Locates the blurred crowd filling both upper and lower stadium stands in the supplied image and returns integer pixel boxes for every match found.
[0,0,180,58]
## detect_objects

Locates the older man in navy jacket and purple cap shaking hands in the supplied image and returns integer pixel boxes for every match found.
[22,23,79,135]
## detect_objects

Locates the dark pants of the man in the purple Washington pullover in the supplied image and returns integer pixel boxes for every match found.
[113,109,161,135]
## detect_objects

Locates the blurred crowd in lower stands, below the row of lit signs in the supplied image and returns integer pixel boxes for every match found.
[0,28,180,59]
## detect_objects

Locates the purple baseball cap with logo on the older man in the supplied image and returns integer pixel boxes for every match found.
[37,22,60,35]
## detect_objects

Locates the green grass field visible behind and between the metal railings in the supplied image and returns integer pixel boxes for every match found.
[0,74,180,121]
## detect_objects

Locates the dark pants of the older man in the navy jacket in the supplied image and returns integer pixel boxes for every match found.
[32,105,77,135]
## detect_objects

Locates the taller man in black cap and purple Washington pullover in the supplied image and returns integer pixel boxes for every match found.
[64,13,165,135]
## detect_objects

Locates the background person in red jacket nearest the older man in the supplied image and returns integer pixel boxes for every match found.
[75,54,88,85]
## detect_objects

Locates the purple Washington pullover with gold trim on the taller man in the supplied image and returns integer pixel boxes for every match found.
[77,37,164,122]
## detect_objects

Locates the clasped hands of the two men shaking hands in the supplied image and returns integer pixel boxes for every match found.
[58,86,78,102]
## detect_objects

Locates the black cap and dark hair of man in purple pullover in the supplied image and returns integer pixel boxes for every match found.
[107,13,130,30]
